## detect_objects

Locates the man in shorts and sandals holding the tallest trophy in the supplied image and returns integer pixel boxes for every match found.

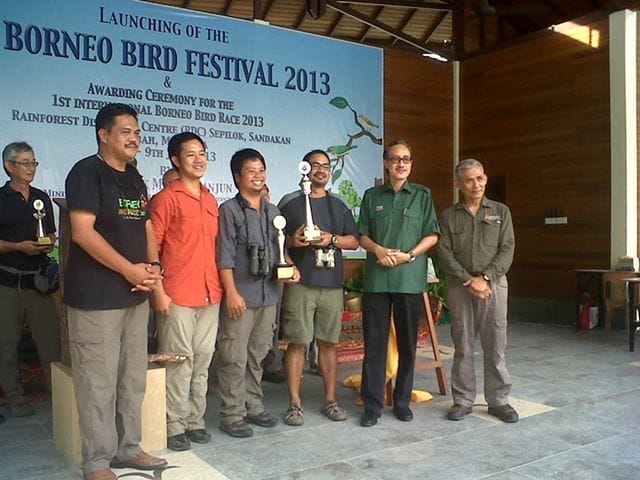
[279,150,359,426]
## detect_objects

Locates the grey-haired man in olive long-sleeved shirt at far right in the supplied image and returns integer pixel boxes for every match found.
[438,159,519,423]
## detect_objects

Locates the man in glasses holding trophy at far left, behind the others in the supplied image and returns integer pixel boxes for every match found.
[0,142,60,417]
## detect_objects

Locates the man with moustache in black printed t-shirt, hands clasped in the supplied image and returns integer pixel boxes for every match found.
[64,104,167,480]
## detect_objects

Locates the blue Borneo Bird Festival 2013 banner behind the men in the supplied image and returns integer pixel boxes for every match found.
[0,0,383,214]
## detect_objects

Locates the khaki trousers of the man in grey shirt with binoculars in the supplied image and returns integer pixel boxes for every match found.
[216,305,276,425]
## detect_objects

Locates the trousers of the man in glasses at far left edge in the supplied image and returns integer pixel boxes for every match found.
[0,286,60,404]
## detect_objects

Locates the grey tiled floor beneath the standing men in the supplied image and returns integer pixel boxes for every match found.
[0,321,640,480]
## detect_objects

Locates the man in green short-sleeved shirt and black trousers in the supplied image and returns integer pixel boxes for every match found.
[359,140,440,427]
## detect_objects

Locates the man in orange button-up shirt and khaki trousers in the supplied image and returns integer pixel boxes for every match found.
[150,132,222,451]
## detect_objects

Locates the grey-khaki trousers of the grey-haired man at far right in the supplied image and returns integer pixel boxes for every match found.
[447,276,511,407]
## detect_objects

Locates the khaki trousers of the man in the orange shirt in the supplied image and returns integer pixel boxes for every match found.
[156,303,220,437]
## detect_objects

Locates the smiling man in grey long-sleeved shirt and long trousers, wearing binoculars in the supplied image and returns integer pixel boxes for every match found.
[216,148,300,437]
